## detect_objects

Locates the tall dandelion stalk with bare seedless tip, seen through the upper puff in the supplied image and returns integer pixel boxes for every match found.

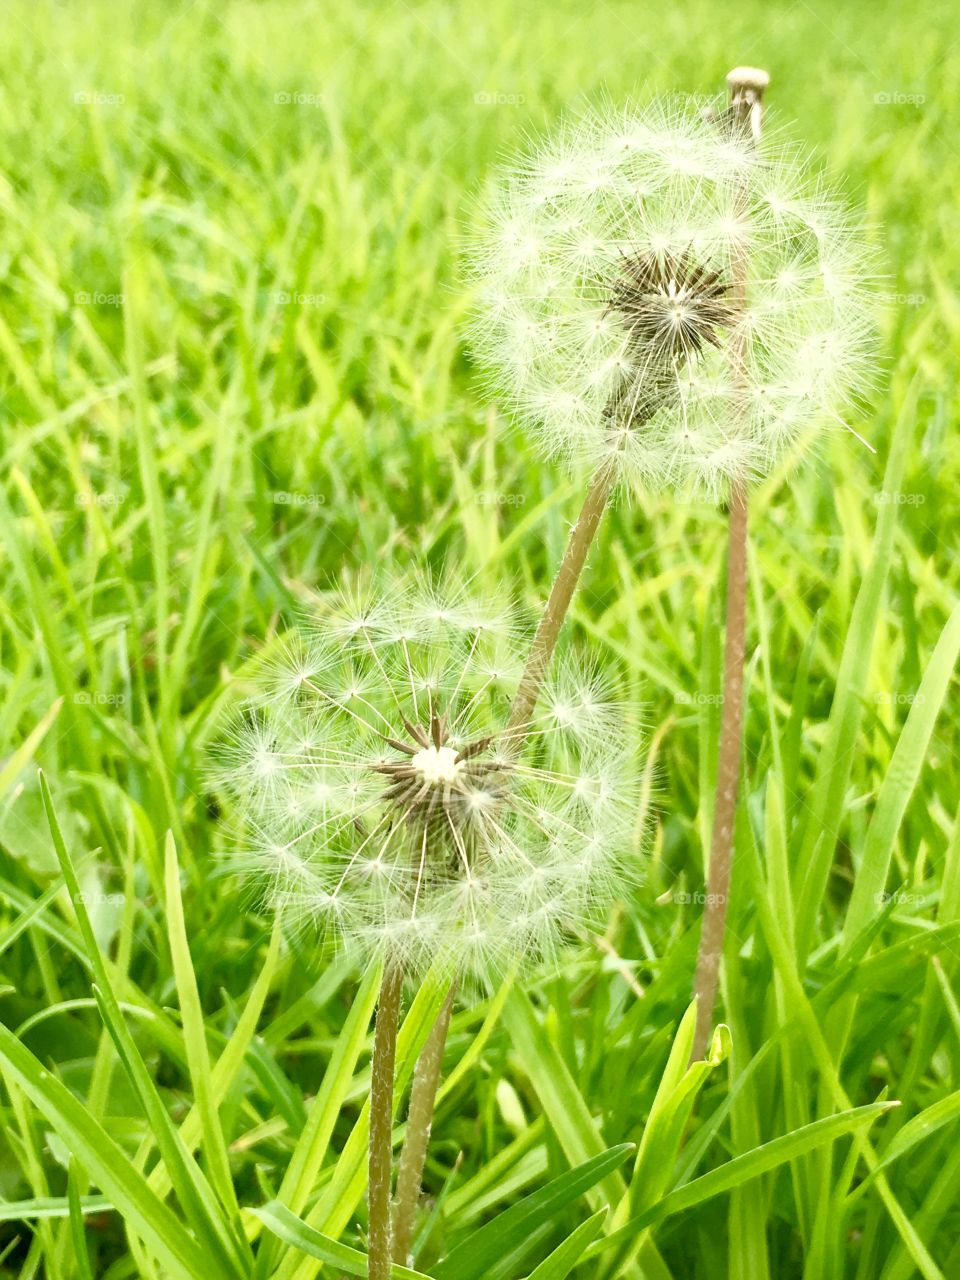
[691,67,769,1061]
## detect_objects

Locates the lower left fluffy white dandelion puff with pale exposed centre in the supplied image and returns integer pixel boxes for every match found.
[218,586,637,978]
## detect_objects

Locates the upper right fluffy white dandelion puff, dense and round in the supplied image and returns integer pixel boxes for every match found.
[468,94,874,498]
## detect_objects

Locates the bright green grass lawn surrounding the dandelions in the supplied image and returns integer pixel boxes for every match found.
[0,0,960,1280]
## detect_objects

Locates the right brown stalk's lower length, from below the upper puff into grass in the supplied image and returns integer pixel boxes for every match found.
[691,484,748,1060]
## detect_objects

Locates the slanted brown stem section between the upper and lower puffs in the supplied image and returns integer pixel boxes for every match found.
[507,463,616,740]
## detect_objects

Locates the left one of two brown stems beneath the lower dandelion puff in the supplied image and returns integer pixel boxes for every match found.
[367,961,403,1280]
